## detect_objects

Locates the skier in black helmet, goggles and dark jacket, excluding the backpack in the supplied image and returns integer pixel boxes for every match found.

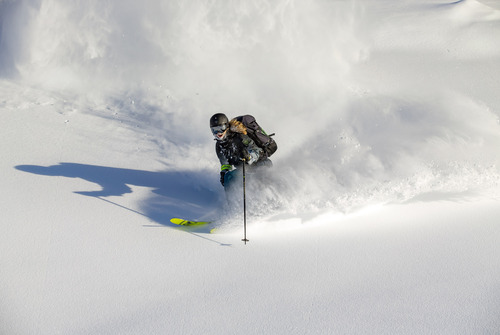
[210,113,272,191]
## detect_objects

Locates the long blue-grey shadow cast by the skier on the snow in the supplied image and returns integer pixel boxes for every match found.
[15,163,220,226]
